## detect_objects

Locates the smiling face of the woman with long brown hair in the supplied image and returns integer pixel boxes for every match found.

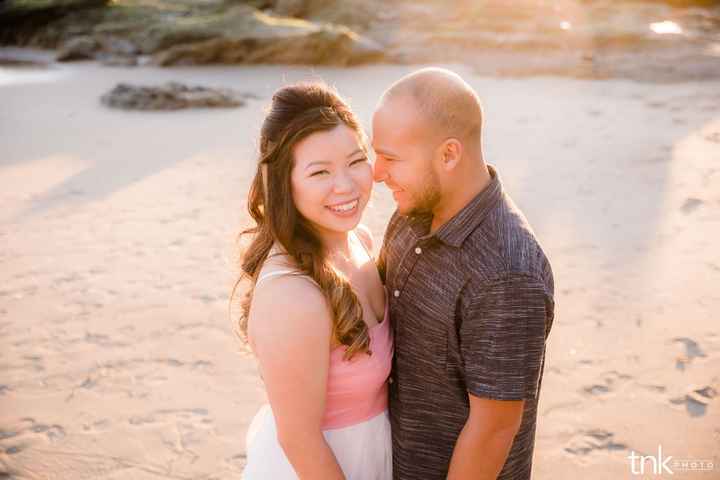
[291,123,373,235]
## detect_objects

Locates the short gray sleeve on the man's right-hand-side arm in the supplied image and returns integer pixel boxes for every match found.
[460,274,551,400]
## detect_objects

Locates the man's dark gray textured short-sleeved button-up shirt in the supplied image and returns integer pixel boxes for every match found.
[378,166,554,480]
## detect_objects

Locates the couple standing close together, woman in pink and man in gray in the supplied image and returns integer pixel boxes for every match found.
[233,68,554,480]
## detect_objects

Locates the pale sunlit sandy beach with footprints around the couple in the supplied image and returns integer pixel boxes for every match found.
[0,54,720,480]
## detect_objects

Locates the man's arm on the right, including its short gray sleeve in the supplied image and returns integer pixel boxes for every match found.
[448,274,546,480]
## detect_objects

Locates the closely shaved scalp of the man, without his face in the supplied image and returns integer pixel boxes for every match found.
[380,67,483,145]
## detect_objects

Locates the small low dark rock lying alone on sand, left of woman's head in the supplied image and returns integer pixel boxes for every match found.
[100,82,249,110]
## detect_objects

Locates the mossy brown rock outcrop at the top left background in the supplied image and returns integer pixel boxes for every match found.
[0,0,383,65]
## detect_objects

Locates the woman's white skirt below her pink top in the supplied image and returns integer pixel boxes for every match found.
[241,404,392,480]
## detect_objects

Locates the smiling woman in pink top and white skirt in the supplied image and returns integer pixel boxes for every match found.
[236,83,393,480]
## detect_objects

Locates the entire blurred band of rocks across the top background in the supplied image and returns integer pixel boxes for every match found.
[0,0,720,78]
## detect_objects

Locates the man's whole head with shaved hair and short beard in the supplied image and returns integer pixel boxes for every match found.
[372,68,489,219]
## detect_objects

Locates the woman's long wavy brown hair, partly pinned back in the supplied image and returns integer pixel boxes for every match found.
[230,83,371,359]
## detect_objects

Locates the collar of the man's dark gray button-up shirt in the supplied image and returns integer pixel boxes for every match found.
[410,164,503,247]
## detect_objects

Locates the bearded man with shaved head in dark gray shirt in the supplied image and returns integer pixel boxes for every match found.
[372,68,554,480]
